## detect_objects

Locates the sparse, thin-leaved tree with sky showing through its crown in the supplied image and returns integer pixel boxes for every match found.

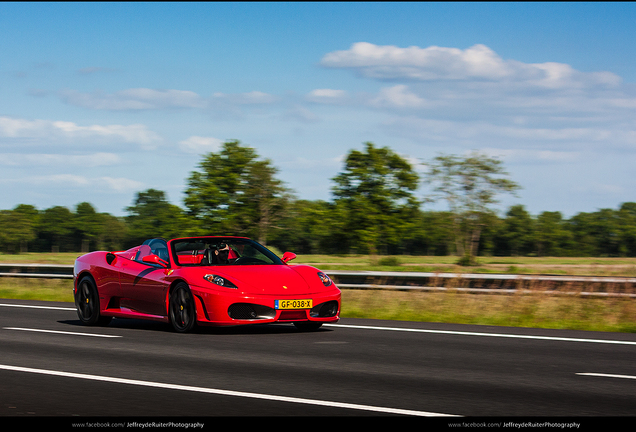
[424,152,519,265]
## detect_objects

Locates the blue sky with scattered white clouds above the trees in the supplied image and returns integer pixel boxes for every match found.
[0,2,636,217]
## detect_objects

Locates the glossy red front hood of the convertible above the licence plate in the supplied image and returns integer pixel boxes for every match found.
[188,265,335,295]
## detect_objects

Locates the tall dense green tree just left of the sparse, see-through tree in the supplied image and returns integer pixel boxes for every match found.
[332,142,419,254]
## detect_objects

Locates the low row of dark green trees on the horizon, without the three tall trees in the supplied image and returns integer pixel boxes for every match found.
[0,198,636,257]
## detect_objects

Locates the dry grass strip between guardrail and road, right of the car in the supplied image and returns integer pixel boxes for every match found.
[342,290,636,332]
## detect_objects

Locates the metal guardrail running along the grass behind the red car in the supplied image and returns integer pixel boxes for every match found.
[0,264,636,297]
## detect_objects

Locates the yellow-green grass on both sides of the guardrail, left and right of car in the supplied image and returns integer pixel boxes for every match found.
[0,253,636,332]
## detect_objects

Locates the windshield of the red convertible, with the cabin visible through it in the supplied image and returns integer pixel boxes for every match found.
[172,237,283,266]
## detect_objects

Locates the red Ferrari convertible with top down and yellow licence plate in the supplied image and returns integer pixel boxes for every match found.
[73,237,340,332]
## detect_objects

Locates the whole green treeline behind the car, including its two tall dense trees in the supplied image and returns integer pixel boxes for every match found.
[0,141,636,257]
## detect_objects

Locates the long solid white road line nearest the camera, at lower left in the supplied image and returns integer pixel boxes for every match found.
[0,365,457,417]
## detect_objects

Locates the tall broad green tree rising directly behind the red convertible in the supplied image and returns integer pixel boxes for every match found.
[185,141,290,244]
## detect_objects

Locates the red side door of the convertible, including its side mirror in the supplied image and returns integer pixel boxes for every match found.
[120,245,170,317]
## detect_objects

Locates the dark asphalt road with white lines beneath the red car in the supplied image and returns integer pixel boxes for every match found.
[0,299,636,421]
